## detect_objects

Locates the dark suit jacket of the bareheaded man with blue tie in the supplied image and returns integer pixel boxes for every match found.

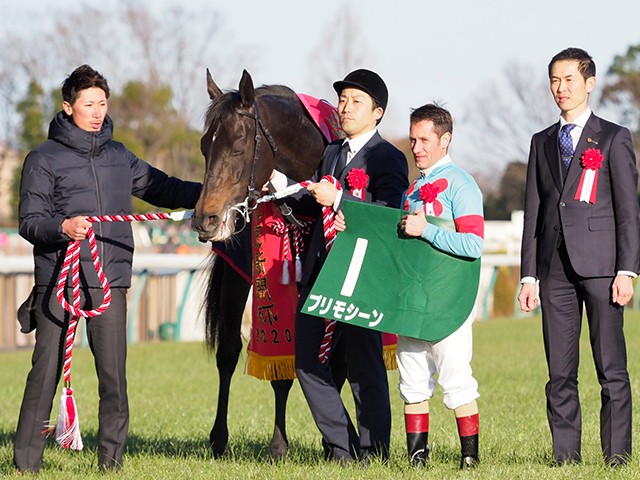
[521,114,640,280]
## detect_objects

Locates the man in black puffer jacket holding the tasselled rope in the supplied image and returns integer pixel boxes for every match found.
[14,65,200,472]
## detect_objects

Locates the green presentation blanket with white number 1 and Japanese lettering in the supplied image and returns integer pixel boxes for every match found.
[302,201,480,342]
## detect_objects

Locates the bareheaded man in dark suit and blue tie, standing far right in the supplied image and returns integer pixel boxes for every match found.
[518,48,640,464]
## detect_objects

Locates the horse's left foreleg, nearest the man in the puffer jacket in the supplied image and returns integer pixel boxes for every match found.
[209,262,251,457]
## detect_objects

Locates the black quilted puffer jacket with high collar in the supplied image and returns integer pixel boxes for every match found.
[19,112,201,287]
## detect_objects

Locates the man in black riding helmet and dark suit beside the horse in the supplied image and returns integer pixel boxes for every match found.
[278,70,408,461]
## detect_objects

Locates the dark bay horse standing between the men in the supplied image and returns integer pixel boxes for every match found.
[192,70,326,458]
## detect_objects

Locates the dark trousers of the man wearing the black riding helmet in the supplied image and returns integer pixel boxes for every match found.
[295,286,391,459]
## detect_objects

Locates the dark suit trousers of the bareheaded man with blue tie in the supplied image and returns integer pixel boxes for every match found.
[540,243,631,461]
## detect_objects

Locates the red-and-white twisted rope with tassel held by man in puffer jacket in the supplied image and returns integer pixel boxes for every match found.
[47,211,192,450]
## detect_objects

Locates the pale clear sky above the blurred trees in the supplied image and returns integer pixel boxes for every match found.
[0,0,640,171]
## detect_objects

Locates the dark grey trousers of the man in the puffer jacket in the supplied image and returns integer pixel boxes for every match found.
[14,287,129,472]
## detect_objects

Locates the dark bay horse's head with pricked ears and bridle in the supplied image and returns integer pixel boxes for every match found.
[191,70,274,242]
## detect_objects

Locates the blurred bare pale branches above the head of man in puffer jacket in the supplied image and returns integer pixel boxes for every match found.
[0,0,245,148]
